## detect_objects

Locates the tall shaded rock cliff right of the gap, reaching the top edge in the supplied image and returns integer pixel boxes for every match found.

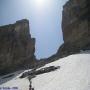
[58,0,90,56]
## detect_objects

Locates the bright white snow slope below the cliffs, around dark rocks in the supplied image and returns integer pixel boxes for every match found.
[0,53,90,90]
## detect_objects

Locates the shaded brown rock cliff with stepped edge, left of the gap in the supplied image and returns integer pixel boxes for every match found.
[0,19,35,74]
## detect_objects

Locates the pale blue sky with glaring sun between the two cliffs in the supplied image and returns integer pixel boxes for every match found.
[0,0,66,59]
